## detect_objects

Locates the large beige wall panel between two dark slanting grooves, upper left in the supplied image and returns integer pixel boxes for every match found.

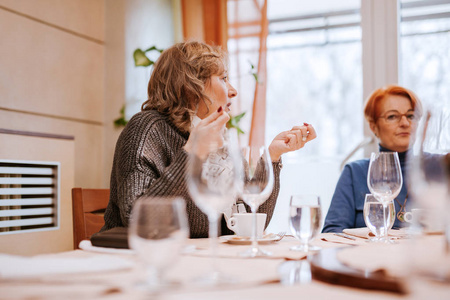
[0,9,104,122]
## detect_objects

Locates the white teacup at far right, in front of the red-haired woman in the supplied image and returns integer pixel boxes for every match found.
[404,208,444,233]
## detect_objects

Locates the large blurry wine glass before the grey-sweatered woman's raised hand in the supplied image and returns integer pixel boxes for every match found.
[187,129,243,285]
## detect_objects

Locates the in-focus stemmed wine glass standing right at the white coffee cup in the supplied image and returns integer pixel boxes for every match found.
[240,146,274,257]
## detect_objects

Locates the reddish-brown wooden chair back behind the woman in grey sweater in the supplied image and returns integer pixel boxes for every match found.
[72,188,109,249]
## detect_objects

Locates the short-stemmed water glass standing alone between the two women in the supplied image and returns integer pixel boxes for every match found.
[289,195,321,252]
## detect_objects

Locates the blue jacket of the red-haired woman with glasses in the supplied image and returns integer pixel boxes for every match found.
[322,146,411,232]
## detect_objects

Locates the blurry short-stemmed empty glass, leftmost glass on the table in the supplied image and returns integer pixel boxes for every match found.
[128,197,189,291]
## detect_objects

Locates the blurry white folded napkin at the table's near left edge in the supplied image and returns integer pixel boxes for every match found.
[0,254,133,279]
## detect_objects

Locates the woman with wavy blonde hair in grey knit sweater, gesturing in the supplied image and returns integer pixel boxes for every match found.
[101,41,316,238]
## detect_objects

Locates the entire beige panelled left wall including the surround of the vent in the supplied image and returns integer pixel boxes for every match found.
[0,0,105,255]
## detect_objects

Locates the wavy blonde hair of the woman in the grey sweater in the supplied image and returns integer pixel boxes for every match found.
[141,41,228,132]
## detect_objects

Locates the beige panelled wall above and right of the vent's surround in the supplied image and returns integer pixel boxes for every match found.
[0,0,105,187]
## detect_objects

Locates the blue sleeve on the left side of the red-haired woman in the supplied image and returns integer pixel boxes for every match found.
[322,165,355,232]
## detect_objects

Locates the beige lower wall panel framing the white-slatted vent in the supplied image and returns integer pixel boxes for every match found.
[0,132,75,255]
